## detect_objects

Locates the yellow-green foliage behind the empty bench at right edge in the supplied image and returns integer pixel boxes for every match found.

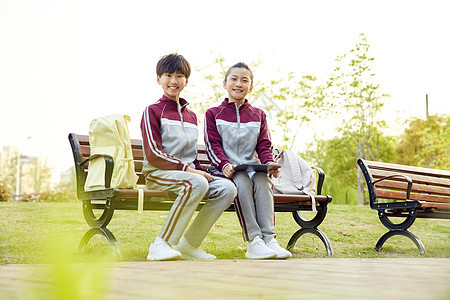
[394,115,450,170]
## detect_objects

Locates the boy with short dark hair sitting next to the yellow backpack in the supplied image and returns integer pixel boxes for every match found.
[141,53,237,260]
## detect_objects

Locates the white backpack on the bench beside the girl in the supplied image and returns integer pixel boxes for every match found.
[272,150,317,212]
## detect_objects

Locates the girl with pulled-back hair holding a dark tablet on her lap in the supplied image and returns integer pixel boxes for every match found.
[205,63,292,259]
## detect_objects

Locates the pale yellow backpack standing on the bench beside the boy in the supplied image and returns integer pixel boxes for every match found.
[84,114,138,191]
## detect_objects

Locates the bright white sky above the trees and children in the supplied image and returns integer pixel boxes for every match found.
[0,0,450,183]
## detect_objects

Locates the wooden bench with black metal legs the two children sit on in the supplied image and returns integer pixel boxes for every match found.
[69,133,333,256]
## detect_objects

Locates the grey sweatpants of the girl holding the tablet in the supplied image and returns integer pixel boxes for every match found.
[232,171,275,243]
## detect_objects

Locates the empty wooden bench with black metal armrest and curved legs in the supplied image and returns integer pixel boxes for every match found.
[358,159,450,254]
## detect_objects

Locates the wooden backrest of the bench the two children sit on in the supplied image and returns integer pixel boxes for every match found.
[69,133,210,190]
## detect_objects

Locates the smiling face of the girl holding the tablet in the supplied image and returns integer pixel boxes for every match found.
[223,68,253,103]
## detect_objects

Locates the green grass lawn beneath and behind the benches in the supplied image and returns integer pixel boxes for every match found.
[0,202,450,264]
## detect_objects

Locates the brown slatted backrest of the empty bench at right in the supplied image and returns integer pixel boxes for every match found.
[358,159,450,210]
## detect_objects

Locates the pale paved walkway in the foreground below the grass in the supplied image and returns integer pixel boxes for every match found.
[0,258,450,300]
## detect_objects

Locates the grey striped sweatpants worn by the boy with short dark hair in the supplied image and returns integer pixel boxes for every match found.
[146,170,237,247]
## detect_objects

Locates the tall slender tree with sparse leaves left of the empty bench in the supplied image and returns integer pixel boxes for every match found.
[325,34,388,204]
